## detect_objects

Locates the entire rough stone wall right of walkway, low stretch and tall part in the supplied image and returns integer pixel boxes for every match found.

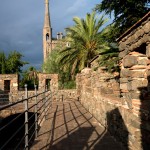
[76,12,150,150]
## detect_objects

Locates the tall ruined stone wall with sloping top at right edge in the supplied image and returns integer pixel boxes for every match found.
[119,12,150,149]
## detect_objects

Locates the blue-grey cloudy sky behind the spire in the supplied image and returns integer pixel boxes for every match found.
[0,0,111,69]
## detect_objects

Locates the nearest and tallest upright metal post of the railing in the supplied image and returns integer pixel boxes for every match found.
[24,84,29,150]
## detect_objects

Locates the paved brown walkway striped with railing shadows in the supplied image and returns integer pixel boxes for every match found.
[31,101,125,150]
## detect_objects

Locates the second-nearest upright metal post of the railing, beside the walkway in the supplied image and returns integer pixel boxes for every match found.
[34,85,38,138]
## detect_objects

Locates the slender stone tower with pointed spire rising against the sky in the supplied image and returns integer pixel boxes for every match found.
[43,0,52,62]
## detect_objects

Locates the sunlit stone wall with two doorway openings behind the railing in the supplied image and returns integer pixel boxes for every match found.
[0,73,58,102]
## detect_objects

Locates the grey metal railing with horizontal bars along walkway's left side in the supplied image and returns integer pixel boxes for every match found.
[0,85,52,150]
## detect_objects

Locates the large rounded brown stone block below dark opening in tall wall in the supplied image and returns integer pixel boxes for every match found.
[123,55,138,68]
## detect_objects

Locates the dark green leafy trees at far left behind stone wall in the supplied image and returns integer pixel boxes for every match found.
[0,51,27,74]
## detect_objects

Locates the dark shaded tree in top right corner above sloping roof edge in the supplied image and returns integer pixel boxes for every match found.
[95,0,150,38]
